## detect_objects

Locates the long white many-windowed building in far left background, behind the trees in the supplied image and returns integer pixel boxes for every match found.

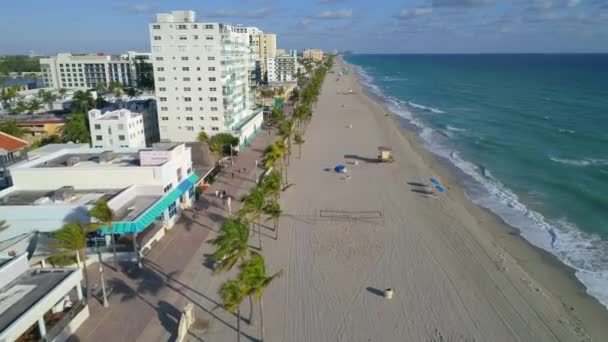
[40,51,149,89]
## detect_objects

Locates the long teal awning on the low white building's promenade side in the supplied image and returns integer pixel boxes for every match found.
[101,173,199,234]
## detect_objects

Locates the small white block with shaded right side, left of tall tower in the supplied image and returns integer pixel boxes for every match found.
[88,99,160,149]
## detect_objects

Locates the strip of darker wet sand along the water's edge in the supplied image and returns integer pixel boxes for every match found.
[339,57,608,337]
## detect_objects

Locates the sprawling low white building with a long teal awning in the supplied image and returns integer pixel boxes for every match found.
[0,144,199,252]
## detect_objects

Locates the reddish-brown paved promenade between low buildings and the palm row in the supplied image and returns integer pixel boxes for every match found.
[70,131,277,342]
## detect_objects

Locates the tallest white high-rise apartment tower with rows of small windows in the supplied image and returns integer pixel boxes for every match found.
[149,11,263,144]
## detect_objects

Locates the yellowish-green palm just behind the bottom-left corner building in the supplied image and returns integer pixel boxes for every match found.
[51,222,91,302]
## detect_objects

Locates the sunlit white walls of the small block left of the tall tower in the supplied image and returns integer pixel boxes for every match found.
[89,109,146,149]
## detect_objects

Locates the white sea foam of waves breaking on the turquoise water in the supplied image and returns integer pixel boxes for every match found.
[346,60,608,308]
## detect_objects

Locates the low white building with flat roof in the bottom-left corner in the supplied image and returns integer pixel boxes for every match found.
[0,253,89,342]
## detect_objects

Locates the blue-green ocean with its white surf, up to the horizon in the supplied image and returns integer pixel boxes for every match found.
[344,54,608,308]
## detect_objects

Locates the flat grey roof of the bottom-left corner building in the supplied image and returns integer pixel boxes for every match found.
[0,269,77,331]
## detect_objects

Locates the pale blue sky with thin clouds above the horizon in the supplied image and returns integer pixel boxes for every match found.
[0,0,608,55]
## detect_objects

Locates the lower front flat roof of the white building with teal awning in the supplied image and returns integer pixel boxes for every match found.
[0,189,122,206]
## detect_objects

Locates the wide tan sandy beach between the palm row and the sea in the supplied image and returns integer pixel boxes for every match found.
[252,58,608,341]
